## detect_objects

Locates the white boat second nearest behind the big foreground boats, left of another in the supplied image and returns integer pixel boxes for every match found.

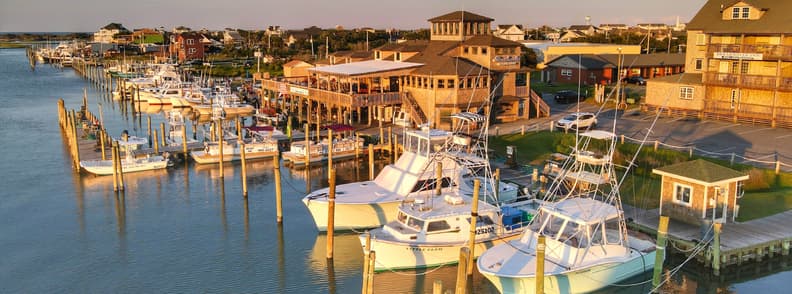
[190,138,278,164]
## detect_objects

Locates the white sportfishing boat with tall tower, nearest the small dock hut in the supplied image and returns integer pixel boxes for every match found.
[476,130,656,293]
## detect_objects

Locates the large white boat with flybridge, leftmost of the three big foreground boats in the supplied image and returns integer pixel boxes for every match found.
[302,128,458,231]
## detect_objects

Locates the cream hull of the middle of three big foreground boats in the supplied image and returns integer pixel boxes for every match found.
[360,233,520,271]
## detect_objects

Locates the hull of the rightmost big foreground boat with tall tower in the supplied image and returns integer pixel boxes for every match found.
[476,251,656,293]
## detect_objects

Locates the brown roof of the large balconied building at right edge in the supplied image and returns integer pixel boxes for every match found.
[687,0,792,34]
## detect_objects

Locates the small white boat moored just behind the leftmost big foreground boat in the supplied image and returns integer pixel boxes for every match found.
[283,137,364,166]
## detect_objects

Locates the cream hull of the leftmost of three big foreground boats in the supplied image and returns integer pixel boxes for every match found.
[303,197,402,232]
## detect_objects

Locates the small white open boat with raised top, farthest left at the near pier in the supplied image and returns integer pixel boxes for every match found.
[80,136,168,176]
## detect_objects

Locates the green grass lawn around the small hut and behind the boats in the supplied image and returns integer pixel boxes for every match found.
[489,131,792,221]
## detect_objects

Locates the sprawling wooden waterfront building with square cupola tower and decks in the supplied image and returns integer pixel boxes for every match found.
[262,11,548,128]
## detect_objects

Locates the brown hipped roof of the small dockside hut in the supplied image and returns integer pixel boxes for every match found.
[652,159,748,183]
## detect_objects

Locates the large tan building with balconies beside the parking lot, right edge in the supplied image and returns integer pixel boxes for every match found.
[644,0,792,127]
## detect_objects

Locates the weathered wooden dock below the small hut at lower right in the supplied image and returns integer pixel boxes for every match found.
[624,205,792,267]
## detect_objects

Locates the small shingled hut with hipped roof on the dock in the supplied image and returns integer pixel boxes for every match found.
[652,159,748,225]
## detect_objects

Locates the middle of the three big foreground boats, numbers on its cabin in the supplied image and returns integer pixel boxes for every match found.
[360,113,541,271]
